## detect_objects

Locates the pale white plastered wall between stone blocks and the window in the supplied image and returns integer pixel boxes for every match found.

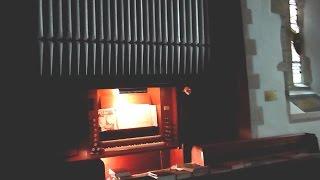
[247,0,320,144]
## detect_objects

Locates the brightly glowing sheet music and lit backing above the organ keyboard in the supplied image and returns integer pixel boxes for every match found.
[99,89,158,131]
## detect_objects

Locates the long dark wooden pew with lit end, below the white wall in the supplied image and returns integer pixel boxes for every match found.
[191,133,319,167]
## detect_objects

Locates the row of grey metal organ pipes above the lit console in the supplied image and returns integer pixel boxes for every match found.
[38,0,211,76]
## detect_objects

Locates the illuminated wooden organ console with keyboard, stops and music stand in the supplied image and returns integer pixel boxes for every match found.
[89,87,179,157]
